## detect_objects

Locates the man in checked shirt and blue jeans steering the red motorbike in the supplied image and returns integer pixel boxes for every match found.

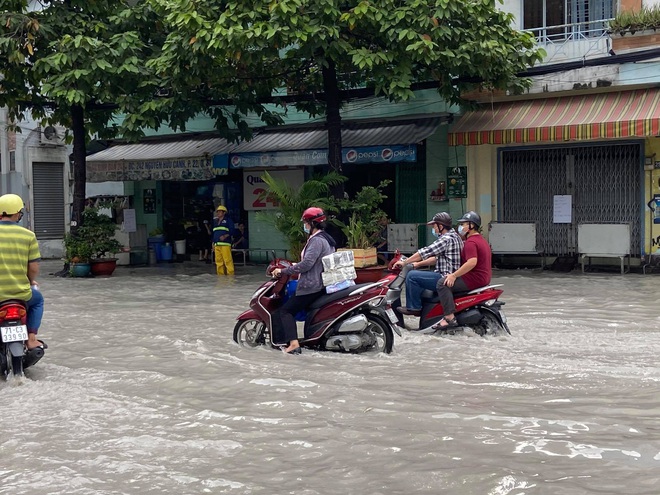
[394,211,463,316]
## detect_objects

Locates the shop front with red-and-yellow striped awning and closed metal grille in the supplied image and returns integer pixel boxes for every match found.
[449,89,660,259]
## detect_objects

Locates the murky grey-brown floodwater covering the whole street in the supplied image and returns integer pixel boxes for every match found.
[0,262,660,495]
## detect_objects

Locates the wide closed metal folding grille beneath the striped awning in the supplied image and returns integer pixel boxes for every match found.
[499,144,641,256]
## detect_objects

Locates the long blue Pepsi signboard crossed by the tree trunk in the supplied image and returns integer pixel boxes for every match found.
[229,144,417,168]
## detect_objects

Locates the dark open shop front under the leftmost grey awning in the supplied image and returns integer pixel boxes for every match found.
[87,138,235,263]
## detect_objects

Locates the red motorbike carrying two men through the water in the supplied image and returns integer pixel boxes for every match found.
[387,258,511,337]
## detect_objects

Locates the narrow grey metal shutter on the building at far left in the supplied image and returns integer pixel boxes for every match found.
[32,162,64,239]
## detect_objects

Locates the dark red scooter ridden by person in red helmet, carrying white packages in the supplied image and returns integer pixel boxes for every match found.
[234,258,401,353]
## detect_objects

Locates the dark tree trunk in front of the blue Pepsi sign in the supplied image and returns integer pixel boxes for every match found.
[323,59,344,199]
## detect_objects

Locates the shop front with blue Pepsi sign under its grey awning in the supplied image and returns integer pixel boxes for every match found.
[218,116,443,252]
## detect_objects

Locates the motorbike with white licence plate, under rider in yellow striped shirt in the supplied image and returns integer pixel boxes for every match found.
[0,299,48,378]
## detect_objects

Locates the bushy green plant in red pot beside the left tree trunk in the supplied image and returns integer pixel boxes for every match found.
[64,207,122,276]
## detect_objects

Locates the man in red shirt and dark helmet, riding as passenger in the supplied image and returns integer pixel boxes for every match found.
[432,211,492,330]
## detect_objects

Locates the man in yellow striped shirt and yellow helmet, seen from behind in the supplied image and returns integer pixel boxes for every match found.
[0,194,44,349]
